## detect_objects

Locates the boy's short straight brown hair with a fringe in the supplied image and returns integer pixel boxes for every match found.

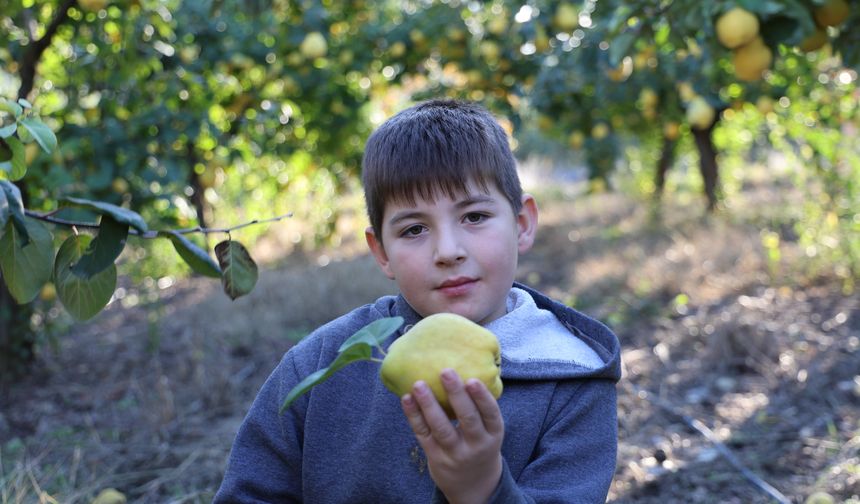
[361,99,523,240]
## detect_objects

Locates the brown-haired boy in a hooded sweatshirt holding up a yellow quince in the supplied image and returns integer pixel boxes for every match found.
[215,100,620,504]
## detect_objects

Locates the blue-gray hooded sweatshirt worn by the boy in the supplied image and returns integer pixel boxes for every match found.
[214,284,621,504]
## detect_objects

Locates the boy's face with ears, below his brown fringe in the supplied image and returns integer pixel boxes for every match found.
[366,179,537,324]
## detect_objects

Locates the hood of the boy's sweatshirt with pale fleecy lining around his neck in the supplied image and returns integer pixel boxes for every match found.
[373,283,621,381]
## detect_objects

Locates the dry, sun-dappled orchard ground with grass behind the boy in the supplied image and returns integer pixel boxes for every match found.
[0,163,860,503]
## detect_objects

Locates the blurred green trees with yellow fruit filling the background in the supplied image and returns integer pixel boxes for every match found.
[0,0,860,370]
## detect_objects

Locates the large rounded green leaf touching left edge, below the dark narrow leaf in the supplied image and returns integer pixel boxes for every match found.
[0,218,54,304]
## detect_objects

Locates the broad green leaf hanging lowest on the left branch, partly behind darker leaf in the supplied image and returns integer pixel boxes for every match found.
[54,235,116,320]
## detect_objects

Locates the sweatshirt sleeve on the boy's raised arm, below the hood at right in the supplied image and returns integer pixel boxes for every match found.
[433,379,618,504]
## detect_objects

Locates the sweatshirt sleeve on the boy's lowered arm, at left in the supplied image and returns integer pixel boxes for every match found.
[213,345,314,503]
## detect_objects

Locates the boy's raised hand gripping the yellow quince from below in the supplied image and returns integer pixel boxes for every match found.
[401,369,505,504]
